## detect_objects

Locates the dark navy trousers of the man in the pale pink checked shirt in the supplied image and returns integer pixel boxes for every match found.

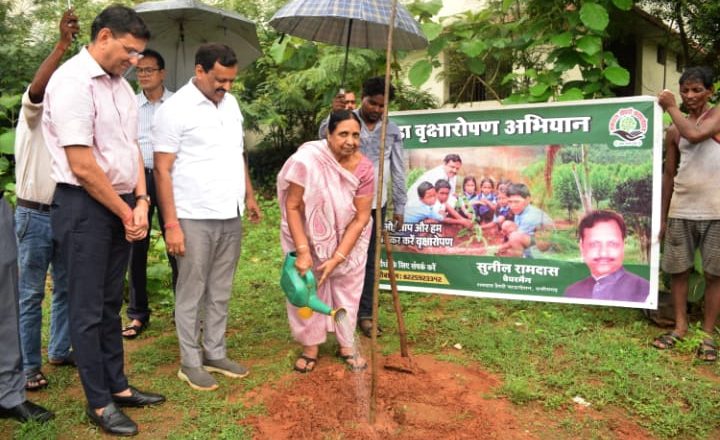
[50,184,135,408]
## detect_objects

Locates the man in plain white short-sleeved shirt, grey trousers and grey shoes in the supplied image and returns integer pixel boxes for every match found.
[153,43,261,391]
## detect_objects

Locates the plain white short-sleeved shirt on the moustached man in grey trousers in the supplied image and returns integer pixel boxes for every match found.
[152,78,245,220]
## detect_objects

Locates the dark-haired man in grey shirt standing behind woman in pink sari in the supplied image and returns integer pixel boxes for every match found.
[320,76,407,338]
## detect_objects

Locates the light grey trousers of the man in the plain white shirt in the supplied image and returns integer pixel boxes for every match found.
[175,216,242,368]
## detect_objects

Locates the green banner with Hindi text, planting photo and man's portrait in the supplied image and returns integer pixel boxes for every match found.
[381,97,662,309]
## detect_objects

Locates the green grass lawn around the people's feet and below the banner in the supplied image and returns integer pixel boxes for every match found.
[0,201,720,439]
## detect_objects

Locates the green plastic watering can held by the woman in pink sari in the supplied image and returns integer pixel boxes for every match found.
[280,252,347,321]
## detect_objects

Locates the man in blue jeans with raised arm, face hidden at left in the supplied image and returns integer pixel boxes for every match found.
[15,10,80,391]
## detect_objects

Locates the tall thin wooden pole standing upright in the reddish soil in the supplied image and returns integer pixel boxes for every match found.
[368,0,397,424]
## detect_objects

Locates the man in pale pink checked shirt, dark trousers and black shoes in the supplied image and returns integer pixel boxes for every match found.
[43,6,165,435]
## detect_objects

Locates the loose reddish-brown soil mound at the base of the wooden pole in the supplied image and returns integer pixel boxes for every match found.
[243,354,653,440]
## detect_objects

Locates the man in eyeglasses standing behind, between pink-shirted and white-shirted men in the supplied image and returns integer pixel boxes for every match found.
[123,49,177,339]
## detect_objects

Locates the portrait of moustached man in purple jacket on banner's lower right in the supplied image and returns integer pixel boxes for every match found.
[565,210,650,302]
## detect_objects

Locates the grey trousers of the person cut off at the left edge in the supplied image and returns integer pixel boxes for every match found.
[0,196,25,408]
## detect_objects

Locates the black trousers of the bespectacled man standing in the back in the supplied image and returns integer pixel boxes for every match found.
[127,168,177,323]
